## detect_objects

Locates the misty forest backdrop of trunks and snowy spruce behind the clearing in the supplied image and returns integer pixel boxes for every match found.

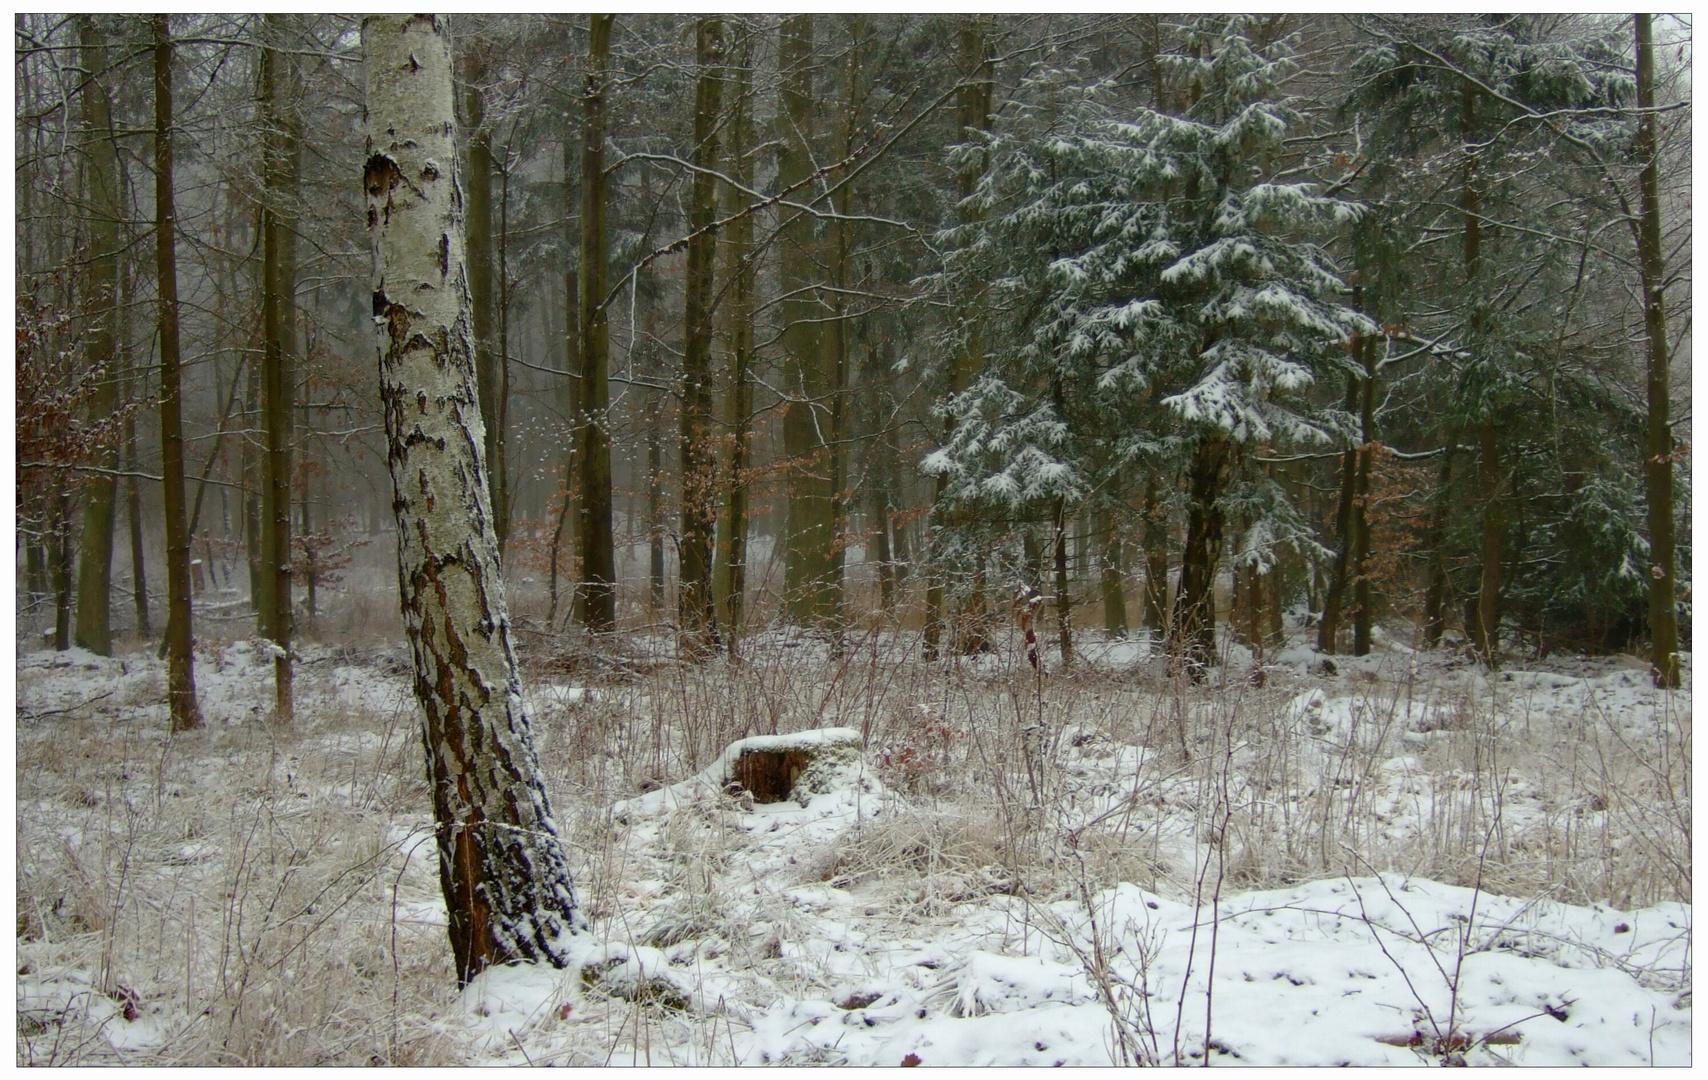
[15,15,1691,683]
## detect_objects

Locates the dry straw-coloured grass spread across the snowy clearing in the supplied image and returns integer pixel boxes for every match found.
[17,618,1691,1065]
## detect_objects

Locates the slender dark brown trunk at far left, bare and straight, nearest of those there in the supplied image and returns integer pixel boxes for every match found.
[154,15,202,731]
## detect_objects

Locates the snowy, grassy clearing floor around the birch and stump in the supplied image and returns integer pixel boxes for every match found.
[17,611,1693,1066]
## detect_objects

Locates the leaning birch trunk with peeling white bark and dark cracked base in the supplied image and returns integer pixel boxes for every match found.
[362,15,582,984]
